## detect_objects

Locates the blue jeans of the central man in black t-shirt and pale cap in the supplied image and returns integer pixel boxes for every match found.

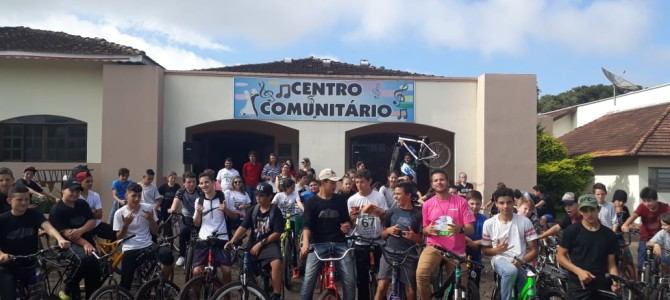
[300,242,356,300]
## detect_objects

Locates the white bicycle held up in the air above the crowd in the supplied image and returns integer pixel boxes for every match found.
[389,136,451,172]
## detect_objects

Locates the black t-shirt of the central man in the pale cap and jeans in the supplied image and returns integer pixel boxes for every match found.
[303,194,350,243]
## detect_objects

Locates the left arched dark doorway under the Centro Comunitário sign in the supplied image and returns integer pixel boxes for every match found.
[184,120,299,173]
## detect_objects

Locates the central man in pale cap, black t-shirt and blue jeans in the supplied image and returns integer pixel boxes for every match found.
[300,168,356,300]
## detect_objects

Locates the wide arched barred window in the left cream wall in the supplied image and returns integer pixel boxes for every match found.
[0,115,86,162]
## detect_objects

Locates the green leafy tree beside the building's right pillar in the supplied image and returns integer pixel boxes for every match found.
[537,128,594,214]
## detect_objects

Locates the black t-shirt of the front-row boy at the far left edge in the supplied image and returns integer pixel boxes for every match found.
[0,208,46,255]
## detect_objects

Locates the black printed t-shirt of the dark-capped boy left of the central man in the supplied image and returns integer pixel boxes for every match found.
[240,204,284,246]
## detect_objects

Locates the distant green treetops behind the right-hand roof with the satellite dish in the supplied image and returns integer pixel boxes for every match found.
[537,84,626,113]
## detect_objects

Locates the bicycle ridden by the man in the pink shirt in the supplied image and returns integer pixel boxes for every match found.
[431,246,484,300]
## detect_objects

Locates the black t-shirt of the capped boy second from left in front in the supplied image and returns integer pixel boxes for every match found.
[49,199,95,244]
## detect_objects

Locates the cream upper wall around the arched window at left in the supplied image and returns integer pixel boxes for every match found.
[0,60,102,163]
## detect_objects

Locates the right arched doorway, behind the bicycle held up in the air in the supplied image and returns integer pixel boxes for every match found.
[345,123,456,191]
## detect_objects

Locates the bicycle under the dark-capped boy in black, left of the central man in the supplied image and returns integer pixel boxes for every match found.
[209,241,274,300]
